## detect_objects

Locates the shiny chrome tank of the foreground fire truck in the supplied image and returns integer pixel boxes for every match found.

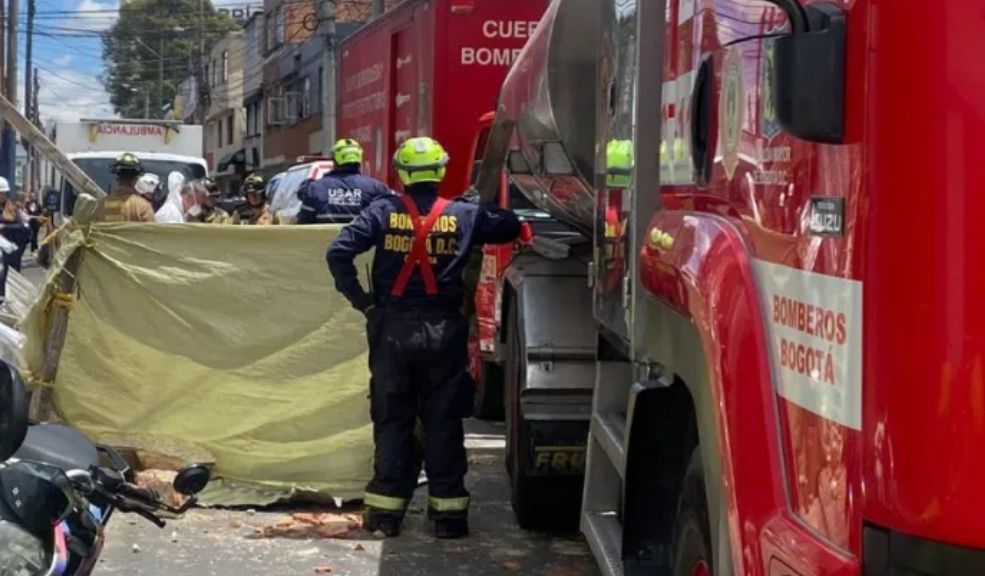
[496,0,606,234]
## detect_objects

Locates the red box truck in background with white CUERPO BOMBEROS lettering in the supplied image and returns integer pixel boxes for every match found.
[337,0,547,196]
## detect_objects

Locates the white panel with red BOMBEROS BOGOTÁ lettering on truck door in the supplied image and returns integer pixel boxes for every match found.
[753,259,862,430]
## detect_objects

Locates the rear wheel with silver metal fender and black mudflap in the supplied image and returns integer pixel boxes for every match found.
[504,245,596,531]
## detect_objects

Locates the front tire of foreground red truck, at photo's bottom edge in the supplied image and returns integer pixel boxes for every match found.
[673,446,712,576]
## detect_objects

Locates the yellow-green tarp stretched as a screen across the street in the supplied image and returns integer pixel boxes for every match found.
[24,224,373,504]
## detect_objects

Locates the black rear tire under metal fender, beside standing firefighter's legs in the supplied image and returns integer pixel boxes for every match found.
[503,300,582,532]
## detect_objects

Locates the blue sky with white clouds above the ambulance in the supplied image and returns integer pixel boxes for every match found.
[25,0,255,121]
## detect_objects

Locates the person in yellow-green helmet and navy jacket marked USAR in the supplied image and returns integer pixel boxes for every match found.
[298,138,392,224]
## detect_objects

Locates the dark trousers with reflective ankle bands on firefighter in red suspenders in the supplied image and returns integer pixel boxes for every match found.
[365,306,475,518]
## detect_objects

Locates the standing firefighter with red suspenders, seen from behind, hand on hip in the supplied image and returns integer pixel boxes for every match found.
[327,137,520,538]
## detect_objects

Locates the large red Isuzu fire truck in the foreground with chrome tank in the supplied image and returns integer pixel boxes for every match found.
[466,0,985,576]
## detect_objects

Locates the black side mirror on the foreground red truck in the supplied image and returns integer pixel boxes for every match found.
[770,0,847,144]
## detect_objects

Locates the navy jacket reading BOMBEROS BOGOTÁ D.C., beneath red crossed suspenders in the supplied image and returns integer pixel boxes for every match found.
[327,192,520,310]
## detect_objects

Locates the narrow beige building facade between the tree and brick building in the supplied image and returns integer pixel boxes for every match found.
[203,30,246,195]
